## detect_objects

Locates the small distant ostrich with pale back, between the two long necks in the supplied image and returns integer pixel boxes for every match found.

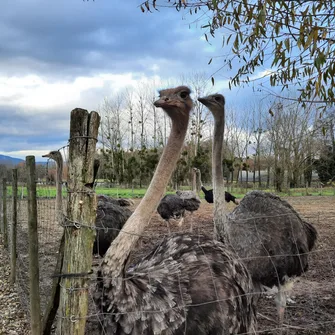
[157,191,201,234]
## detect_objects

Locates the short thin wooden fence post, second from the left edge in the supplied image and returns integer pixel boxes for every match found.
[10,169,17,284]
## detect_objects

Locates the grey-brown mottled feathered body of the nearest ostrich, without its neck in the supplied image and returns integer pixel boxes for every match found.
[96,234,256,335]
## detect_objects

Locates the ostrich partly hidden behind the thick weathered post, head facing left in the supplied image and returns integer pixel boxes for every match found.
[42,151,132,257]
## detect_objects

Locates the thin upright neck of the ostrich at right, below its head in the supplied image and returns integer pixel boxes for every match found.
[212,116,229,241]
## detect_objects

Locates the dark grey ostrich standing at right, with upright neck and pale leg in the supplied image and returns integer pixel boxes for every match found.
[198,94,317,325]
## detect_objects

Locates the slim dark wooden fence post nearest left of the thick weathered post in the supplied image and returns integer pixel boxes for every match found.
[26,156,41,335]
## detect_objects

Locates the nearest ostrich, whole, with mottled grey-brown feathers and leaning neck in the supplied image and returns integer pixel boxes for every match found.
[94,86,256,335]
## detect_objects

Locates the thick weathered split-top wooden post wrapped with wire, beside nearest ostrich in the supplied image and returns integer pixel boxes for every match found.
[57,108,100,335]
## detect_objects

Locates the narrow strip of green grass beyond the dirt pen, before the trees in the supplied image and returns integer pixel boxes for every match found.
[3,185,335,199]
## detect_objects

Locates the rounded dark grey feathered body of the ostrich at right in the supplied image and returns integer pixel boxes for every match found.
[228,191,317,287]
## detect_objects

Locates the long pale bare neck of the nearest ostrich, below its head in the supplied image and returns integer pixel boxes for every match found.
[102,118,188,276]
